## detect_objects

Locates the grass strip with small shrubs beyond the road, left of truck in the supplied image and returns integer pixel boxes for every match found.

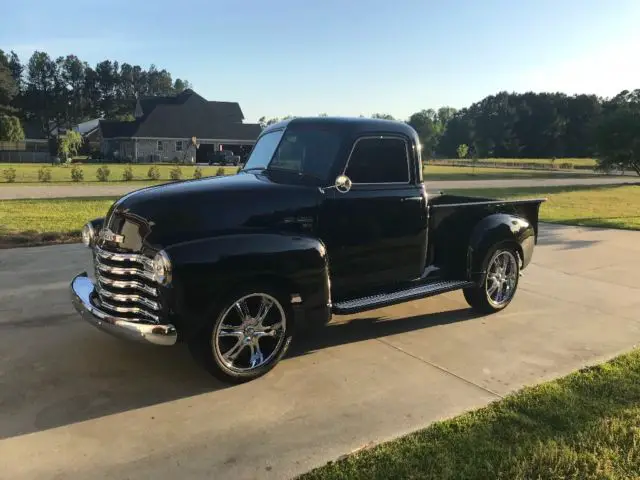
[0,163,238,185]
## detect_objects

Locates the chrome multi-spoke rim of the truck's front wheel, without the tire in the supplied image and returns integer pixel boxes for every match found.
[212,293,287,373]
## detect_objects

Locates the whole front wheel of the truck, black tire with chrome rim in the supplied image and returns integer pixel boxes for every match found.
[189,286,293,383]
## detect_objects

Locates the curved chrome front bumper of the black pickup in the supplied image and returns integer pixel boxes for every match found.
[71,273,178,346]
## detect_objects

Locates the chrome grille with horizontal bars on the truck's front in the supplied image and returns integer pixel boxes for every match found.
[94,246,162,323]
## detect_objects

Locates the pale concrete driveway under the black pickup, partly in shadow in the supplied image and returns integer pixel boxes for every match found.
[0,224,640,479]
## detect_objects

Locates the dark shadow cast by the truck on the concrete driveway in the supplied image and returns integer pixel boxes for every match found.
[0,309,476,439]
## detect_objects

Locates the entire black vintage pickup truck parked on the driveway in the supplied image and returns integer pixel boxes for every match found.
[71,118,544,382]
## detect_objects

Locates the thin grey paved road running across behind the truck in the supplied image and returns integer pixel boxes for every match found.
[0,176,640,200]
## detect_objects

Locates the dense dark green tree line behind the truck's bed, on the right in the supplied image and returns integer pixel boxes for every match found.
[259,89,640,175]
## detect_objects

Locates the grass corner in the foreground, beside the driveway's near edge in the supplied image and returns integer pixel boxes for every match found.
[300,350,640,480]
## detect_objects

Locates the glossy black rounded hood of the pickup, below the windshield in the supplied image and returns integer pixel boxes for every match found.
[104,173,322,251]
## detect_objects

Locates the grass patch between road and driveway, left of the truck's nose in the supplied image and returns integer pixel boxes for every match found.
[0,197,115,248]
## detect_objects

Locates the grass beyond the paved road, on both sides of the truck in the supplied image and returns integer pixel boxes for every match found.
[0,164,592,187]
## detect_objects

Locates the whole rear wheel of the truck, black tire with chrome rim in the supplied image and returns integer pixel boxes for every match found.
[463,246,520,313]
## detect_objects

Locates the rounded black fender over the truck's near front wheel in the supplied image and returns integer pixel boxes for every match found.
[166,233,330,336]
